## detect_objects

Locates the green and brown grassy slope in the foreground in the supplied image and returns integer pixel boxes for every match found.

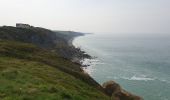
[0,40,109,100]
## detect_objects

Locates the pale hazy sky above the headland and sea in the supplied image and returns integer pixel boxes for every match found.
[0,0,170,33]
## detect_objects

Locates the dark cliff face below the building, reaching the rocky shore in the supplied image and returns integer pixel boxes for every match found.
[0,26,90,59]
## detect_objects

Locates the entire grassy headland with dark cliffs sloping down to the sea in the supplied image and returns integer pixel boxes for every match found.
[0,26,140,100]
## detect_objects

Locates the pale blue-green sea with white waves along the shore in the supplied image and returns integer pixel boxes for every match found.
[73,34,170,100]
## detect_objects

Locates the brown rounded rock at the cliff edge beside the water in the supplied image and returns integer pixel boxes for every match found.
[103,81,143,100]
